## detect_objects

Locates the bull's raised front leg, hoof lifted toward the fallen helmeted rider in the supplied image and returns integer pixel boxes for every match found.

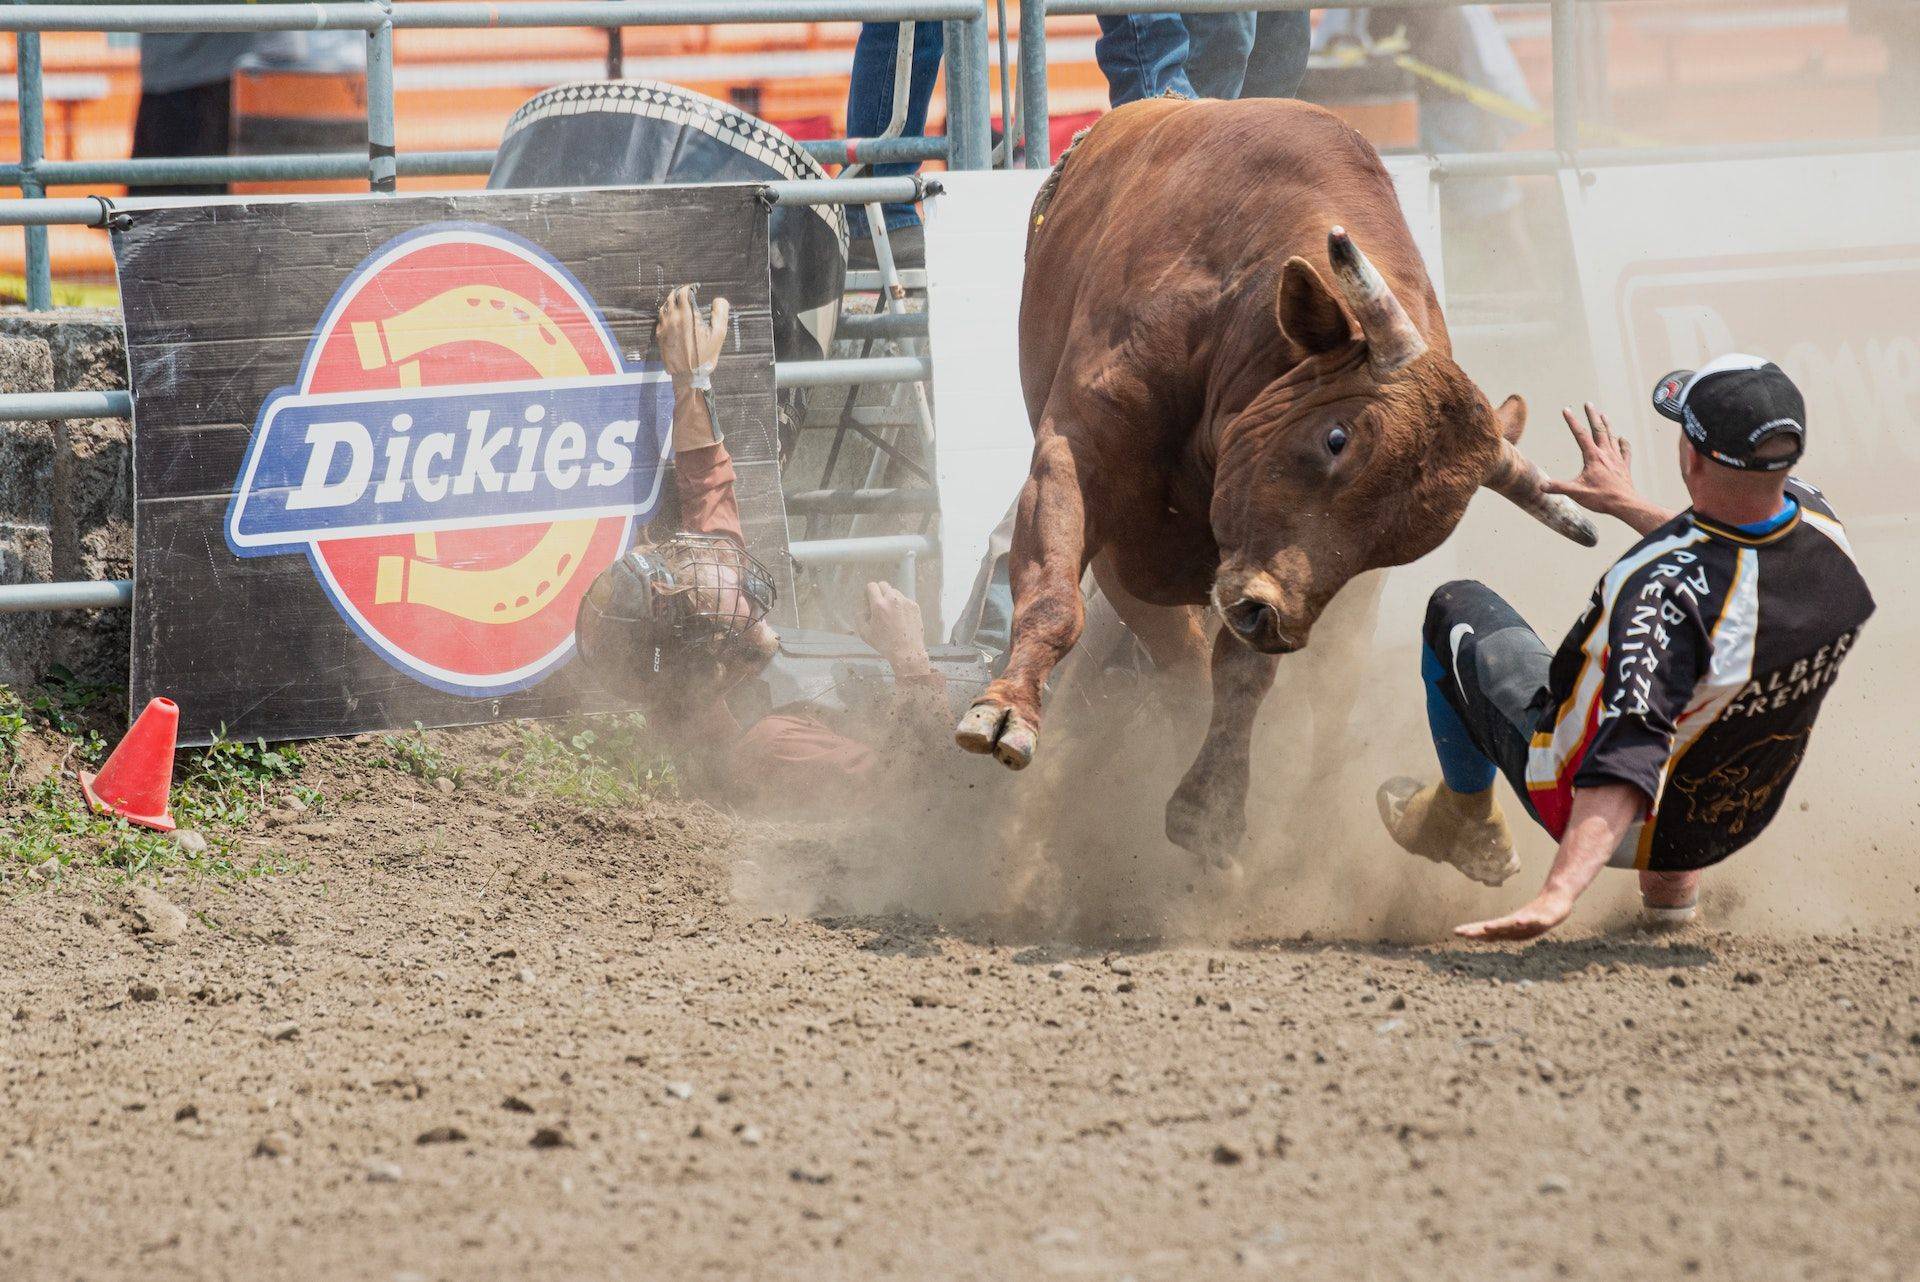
[954,432,1094,770]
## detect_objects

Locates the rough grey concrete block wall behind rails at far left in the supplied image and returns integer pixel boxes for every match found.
[0,311,132,685]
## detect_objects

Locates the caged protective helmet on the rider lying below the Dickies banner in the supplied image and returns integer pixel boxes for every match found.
[574,534,776,689]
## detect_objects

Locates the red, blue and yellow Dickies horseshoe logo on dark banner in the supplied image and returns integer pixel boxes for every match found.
[227,223,672,697]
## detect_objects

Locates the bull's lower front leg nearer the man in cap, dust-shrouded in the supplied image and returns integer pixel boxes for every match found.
[1167,628,1281,867]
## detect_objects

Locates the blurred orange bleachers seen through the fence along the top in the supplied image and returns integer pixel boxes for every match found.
[0,4,1885,297]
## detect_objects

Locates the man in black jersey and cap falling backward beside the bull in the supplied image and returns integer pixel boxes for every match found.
[1379,355,1874,938]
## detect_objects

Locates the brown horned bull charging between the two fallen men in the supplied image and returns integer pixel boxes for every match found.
[956,98,1594,860]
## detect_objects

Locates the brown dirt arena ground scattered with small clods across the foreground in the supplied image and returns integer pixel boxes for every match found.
[0,710,1920,1282]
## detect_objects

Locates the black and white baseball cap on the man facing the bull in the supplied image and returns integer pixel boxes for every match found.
[1653,353,1807,472]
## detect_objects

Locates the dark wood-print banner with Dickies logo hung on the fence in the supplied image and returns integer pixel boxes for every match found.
[113,184,791,743]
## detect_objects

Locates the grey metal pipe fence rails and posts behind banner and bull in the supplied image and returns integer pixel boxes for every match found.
[0,0,1920,612]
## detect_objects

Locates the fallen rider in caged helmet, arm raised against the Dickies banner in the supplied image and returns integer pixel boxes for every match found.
[576,288,987,808]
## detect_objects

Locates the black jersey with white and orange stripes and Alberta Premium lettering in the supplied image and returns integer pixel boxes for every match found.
[1526,480,1874,869]
